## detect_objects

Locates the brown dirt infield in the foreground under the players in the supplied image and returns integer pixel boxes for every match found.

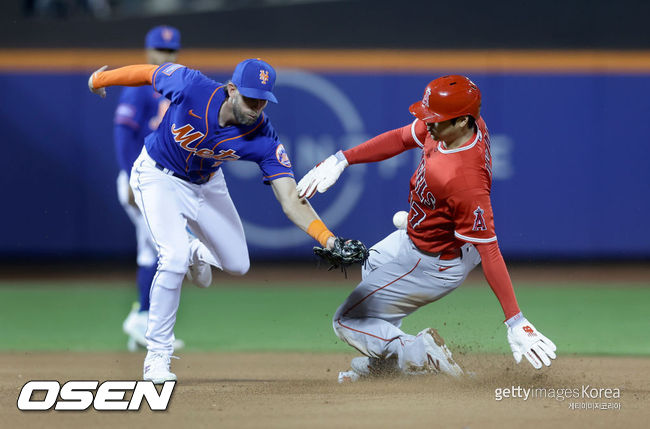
[0,352,650,429]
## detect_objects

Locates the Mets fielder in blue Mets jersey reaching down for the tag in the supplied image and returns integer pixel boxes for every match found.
[88,59,344,383]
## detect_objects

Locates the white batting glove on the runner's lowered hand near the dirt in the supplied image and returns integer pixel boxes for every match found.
[505,312,557,369]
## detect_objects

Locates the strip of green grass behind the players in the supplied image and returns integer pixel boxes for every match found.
[0,281,650,355]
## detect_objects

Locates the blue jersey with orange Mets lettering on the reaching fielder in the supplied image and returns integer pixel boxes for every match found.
[145,63,293,183]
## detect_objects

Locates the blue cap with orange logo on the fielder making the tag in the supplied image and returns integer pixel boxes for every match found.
[231,58,278,103]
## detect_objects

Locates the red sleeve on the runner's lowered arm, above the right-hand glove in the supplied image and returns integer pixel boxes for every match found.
[474,242,520,320]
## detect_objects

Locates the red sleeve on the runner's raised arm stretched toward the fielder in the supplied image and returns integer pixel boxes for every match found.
[343,124,417,164]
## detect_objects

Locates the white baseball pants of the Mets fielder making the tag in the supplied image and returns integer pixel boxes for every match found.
[130,148,250,354]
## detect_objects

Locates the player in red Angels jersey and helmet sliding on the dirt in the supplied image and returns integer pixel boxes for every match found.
[298,75,556,381]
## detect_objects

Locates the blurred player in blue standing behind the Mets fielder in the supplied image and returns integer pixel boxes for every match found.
[113,26,183,351]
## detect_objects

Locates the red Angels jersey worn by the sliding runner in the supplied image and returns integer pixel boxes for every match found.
[402,118,497,253]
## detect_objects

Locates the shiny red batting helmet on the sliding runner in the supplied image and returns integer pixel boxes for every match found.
[409,75,481,122]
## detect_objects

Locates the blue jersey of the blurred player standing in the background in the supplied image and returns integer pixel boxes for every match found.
[113,85,170,175]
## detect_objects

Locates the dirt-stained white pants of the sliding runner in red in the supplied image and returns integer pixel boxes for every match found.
[333,230,481,370]
